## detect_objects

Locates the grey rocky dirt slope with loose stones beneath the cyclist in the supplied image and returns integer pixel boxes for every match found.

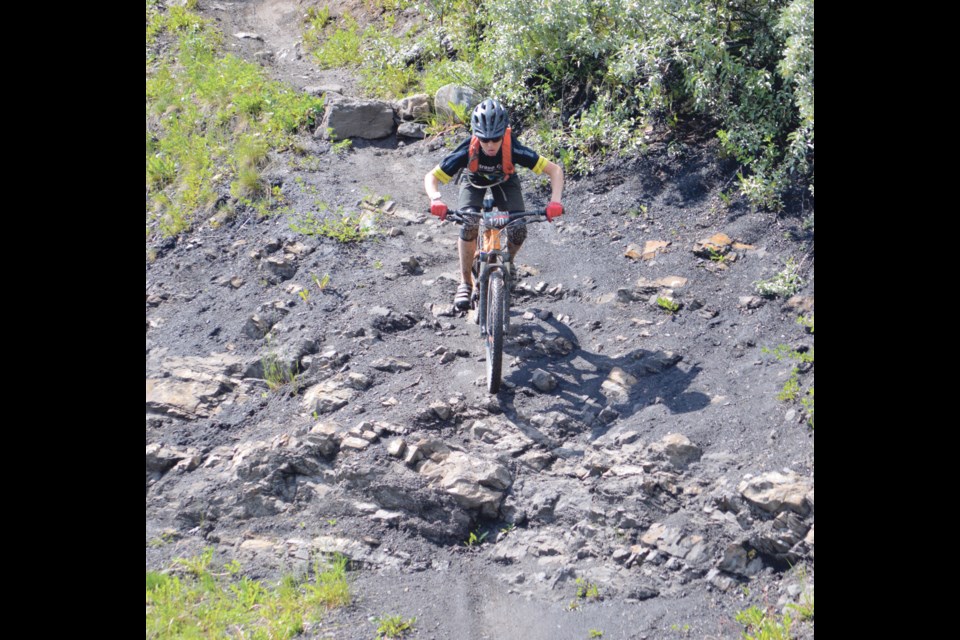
[145,1,814,640]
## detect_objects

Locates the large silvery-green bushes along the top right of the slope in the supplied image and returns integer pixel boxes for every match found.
[310,0,814,210]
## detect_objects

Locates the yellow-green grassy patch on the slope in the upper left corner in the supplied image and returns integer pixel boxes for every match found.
[146,2,323,237]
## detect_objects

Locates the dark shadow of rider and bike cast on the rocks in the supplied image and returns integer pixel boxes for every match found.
[500,317,710,439]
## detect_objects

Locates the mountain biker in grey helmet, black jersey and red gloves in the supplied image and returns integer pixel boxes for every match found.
[423,98,563,309]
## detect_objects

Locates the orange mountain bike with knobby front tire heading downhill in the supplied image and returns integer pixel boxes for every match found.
[436,195,547,393]
